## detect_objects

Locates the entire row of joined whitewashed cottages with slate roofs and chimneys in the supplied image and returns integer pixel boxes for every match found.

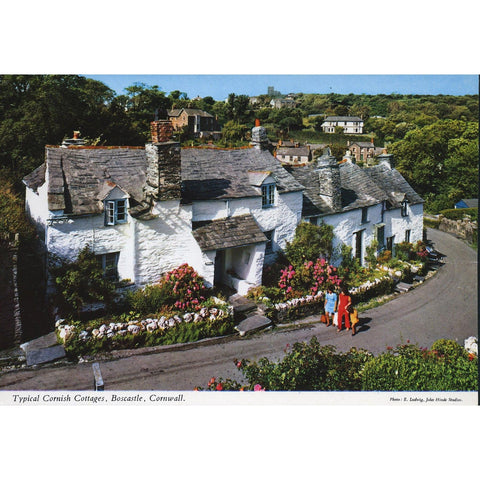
[24,120,423,294]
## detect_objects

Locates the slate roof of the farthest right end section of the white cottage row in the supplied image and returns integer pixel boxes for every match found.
[364,163,424,208]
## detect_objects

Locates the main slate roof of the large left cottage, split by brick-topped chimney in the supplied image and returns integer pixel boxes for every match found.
[24,147,303,215]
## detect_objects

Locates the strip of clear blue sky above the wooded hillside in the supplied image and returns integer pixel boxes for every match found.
[85,74,479,100]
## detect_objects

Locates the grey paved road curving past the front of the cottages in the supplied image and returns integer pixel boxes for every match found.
[0,230,478,390]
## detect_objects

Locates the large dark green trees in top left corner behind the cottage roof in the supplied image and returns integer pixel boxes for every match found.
[0,75,141,189]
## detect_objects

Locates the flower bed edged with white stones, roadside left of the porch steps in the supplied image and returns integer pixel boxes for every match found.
[55,297,234,356]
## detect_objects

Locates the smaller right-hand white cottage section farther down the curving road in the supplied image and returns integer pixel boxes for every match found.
[289,148,423,264]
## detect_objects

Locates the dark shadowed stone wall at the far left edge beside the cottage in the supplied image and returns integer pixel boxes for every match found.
[0,237,22,350]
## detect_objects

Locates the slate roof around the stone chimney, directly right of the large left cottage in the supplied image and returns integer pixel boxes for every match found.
[289,162,388,217]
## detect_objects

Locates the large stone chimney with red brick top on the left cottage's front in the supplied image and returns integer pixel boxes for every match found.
[145,120,182,200]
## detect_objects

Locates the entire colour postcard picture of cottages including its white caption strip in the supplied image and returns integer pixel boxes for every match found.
[0,74,479,405]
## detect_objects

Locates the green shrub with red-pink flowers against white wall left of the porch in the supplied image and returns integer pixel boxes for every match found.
[126,264,207,314]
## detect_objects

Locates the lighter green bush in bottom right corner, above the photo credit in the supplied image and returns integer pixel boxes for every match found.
[362,340,478,391]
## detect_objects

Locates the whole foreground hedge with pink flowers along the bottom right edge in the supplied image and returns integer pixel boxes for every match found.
[197,337,478,391]
